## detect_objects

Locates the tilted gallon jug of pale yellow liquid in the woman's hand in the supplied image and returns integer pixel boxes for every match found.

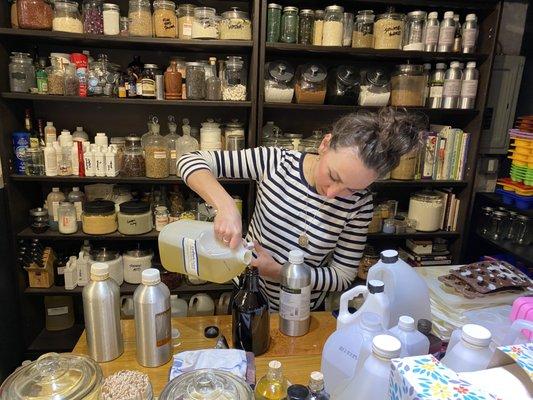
[158,220,253,283]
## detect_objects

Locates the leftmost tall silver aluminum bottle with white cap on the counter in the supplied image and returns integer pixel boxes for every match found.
[82,263,124,362]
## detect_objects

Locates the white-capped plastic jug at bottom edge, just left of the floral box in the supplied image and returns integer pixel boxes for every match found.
[338,335,401,400]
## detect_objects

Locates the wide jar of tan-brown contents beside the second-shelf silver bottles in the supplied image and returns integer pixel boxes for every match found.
[391,64,426,107]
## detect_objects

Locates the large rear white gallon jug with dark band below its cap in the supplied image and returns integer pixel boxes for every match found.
[367,250,431,329]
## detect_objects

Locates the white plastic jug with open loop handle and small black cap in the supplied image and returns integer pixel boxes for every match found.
[337,280,390,329]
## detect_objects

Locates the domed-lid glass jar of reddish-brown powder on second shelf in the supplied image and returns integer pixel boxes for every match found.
[294,63,328,104]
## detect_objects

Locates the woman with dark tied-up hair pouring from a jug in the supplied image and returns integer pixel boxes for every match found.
[178,109,421,310]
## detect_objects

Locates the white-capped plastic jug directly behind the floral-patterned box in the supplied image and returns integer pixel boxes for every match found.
[442,324,492,372]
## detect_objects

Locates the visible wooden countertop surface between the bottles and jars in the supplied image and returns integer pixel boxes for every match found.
[73,312,336,395]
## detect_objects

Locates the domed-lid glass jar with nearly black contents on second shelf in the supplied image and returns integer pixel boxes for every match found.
[326,65,360,106]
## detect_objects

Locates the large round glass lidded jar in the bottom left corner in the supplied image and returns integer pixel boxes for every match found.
[0,353,103,400]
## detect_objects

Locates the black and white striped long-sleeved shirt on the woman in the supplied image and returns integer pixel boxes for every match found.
[178,147,372,311]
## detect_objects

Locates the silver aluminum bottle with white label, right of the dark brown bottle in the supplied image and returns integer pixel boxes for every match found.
[279,250,311,336]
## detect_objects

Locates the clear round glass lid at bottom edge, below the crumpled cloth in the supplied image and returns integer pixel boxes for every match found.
[159,369,254,400]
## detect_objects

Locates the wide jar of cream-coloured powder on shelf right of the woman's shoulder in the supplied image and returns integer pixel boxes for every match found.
[408,190,444,232]
